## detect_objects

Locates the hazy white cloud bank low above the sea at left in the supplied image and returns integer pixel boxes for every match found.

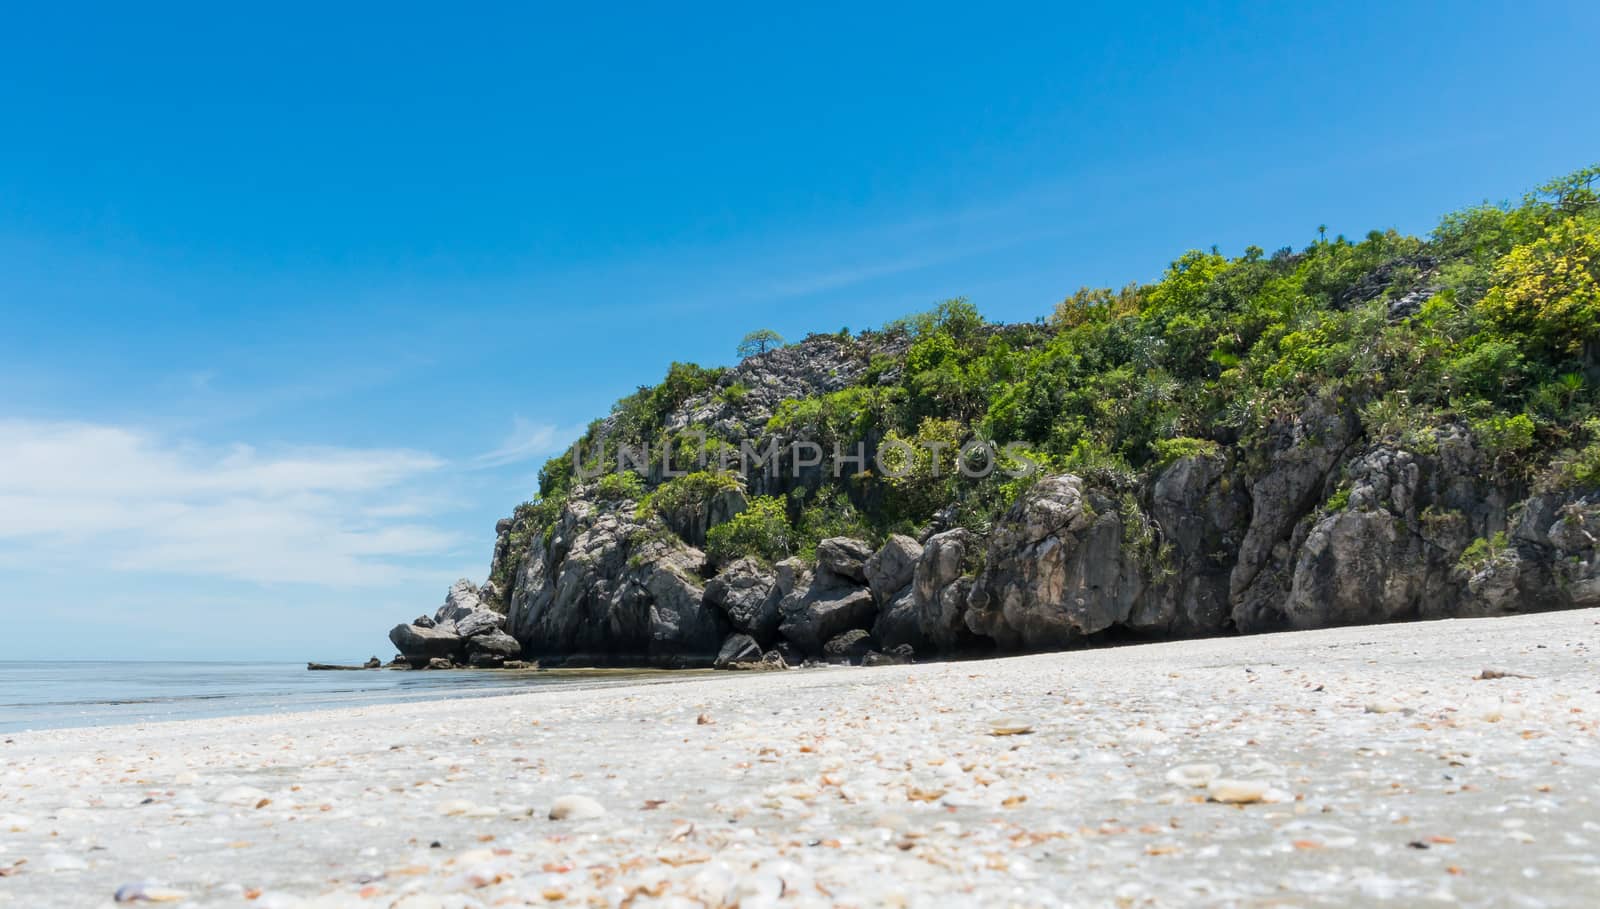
[0,419,456,587]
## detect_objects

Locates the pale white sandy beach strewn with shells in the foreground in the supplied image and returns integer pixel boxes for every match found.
[0,611,1600,907]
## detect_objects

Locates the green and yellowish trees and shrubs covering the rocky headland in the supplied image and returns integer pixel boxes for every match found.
[514,166,1600,563]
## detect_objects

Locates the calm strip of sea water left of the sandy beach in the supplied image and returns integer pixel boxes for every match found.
[0,661,694,731]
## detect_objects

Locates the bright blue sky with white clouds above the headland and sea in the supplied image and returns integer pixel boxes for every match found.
[0,3,1600,659]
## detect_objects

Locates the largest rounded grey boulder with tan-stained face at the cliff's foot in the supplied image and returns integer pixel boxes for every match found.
[966,475,1144,651]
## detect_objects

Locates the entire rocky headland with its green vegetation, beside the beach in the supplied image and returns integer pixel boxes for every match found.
[390,174,1600,667]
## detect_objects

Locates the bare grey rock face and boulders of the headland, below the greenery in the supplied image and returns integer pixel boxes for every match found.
[377,329,1600,667]
